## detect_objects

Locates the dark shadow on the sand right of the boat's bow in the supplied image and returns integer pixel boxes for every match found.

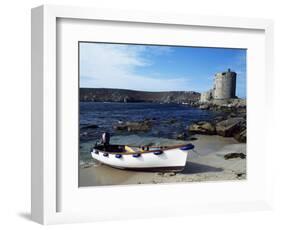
[179,162,223,174]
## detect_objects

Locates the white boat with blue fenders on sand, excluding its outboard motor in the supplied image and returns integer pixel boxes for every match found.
[91,143,194,171]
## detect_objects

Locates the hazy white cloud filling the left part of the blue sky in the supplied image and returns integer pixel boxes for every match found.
[80,43,188,91]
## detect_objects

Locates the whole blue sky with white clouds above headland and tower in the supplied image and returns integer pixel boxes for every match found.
[80,42,246,98]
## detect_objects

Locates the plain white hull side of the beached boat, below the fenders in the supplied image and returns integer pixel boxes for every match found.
[91,148,188,172]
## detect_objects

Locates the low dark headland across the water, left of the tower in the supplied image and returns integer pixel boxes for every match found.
[80,88,200,104]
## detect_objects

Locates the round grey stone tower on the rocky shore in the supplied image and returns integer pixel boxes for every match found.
[213,69,236,100]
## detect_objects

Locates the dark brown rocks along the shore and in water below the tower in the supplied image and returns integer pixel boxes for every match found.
[109,99,247,143]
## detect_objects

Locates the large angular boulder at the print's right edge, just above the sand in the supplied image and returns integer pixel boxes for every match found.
[216,117,245,137]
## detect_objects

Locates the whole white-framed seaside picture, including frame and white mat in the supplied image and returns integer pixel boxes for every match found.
[31,6,273,224]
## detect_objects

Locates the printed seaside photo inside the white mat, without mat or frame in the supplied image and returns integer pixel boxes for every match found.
[78,41,247,187]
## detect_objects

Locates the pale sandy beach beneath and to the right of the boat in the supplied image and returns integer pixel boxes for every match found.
[79,135,246,187]
